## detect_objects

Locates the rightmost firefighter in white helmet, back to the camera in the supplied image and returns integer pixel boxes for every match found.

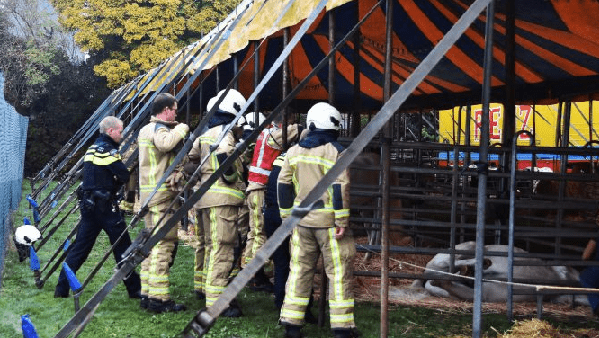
[277,102,359,338]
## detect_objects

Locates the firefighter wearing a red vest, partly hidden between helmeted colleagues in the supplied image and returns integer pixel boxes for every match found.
[244,111,302,292]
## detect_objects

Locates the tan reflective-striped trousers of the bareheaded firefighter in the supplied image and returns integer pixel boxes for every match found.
[140,203,178,301]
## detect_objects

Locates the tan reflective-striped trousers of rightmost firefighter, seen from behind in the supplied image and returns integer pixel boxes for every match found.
[281,225,356,329]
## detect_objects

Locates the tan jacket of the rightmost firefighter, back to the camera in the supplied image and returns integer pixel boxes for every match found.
[278,143,349,228]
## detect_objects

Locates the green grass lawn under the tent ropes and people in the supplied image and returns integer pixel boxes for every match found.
[0,182,599,338]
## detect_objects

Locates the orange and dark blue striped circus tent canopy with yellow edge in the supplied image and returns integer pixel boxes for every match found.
[141,0,599,110]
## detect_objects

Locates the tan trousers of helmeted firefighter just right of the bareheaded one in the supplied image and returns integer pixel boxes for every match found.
[202,205,239,307]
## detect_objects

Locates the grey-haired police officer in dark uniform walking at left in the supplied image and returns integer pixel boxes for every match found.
[54,116,141,298]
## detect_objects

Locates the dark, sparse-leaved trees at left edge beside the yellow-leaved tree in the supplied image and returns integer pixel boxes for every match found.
[0,0,109,175]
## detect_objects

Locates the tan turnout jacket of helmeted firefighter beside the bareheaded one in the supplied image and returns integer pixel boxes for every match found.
[188,125,245,209]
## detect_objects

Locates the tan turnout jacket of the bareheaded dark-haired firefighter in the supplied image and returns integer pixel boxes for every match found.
[137,116,189,207]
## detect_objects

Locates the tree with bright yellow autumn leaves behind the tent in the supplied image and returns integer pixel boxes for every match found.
[51,0,240,88]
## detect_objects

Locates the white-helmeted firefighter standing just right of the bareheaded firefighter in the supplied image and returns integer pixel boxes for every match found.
[188,89,246,317]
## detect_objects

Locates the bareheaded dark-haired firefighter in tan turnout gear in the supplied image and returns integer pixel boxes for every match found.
[137,93,189,313]
